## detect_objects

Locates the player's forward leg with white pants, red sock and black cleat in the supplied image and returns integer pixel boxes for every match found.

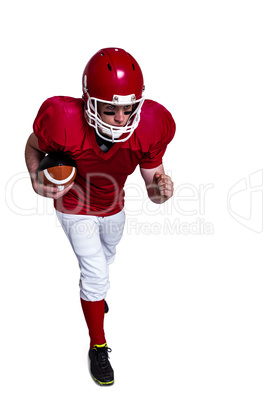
[57,213,114,385]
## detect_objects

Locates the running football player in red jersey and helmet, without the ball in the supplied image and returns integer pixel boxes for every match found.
[25,48,175,385]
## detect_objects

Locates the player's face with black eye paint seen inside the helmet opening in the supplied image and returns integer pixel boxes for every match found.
[98,102,132,127]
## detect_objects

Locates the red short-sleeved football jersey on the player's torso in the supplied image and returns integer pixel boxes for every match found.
[33,96,175,216]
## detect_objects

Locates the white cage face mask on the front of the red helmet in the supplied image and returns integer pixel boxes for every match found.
[85,95,145,142]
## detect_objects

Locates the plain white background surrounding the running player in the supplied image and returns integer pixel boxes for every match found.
[0,0,268,402]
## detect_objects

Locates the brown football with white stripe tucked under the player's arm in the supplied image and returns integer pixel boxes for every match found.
[37,152,77,190]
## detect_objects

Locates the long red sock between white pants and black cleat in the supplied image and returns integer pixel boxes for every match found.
[81,298,106,349]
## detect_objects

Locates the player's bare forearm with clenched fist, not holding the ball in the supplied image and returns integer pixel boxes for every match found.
[140,164,174,204]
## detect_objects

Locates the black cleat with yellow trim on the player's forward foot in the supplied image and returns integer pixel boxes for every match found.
[88,343,114,385]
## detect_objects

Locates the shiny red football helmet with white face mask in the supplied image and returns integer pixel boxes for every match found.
[82,48,144,142]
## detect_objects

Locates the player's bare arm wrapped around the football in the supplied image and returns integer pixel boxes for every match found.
[25,133,73,199]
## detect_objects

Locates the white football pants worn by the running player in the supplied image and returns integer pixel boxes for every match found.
[56,210,125,301]
